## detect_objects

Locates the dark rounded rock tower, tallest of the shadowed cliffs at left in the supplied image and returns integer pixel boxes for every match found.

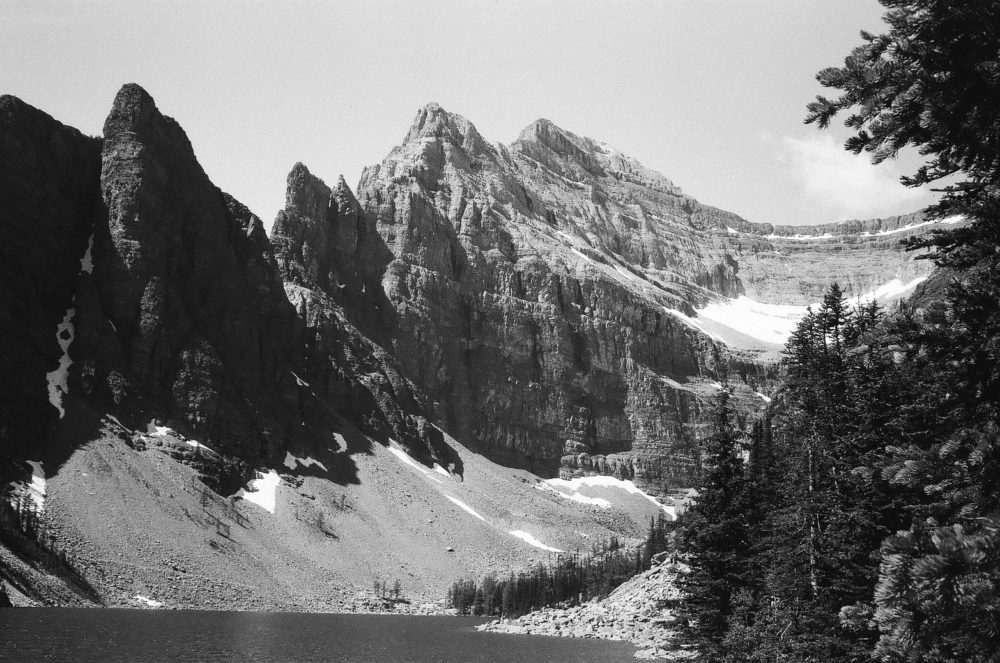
[64,85,301,459]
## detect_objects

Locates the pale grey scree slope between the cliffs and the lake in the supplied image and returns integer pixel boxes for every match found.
[0,422,672,613]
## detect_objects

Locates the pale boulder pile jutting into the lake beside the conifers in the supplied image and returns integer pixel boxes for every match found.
[479,562,694,661]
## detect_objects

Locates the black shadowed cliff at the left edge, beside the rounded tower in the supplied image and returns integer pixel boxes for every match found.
[0,96,101,454]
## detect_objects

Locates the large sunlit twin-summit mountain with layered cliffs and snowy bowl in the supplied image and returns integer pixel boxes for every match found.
[342,104,930,490]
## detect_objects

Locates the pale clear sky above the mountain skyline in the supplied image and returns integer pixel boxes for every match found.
[0,0,934,225]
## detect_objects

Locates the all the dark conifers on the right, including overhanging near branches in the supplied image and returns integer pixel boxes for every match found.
[677,0,1000,663]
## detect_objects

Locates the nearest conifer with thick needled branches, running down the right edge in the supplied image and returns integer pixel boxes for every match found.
[807,0,1000,661]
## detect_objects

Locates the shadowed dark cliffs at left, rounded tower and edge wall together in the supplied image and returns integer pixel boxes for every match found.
[0,85,448,492]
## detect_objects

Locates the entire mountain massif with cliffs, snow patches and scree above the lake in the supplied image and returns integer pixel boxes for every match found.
[0,84,951,611]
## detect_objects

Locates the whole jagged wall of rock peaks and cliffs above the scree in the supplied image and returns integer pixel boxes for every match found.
[0,85,940,492]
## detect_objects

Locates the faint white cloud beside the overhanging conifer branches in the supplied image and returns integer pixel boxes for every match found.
[781,134,932,218]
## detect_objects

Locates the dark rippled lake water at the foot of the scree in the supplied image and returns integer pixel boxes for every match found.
[0,608,636,663]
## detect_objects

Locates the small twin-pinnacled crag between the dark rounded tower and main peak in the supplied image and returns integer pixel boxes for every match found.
[271,164,462,474]
